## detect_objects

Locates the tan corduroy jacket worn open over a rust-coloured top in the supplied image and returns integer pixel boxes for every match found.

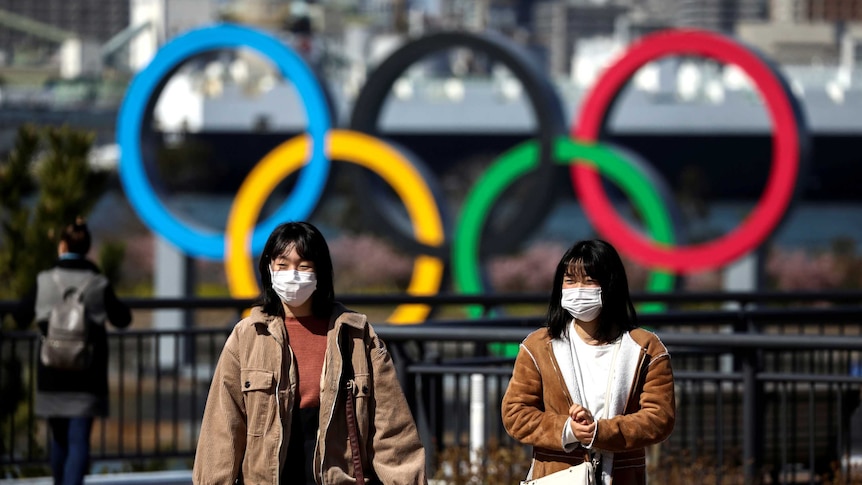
[192,305,427,485]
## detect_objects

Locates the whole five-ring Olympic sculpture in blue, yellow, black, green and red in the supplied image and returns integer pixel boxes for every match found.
[118,24,809,323]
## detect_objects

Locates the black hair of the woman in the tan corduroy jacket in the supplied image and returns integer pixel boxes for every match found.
[255,222,335,318]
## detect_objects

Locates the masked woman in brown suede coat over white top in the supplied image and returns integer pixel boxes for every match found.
[502,240,675,484]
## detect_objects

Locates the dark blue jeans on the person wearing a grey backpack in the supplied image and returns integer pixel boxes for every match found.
[48,417,93,485]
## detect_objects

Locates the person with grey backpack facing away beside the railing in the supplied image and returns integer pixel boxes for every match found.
[15,218,132,485]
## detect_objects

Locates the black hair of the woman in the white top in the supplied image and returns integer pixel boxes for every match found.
[548,239,637,342]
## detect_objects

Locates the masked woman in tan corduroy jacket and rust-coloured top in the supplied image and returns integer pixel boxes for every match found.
[192,222,427,485]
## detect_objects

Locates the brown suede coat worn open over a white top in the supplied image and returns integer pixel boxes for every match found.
[502,328,676,484]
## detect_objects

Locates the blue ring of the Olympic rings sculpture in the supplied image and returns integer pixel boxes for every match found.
[117,24,332,259]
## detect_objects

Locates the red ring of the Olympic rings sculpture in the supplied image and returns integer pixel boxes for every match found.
[570,30,805,273]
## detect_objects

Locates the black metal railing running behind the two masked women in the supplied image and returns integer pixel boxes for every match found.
[0,293,862,483]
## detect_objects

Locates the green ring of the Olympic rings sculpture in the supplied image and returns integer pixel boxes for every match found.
[452,137,676,317]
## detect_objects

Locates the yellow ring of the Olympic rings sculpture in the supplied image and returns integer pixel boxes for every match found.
[225,130,444,324]
